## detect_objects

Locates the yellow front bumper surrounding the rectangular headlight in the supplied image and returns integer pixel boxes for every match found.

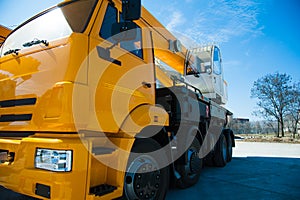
[0,137,89,199]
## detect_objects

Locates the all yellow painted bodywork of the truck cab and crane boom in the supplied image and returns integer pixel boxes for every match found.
[0,0,185,200]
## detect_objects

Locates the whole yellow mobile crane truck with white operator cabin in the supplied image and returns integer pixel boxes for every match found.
[0,0,234,200]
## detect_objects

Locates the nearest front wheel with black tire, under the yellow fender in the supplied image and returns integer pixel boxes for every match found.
[121,139,169,200]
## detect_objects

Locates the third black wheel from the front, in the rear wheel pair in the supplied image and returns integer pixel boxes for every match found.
[214,134,227,167]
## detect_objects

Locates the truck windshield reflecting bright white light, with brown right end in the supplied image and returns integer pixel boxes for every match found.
[1,0,97,56]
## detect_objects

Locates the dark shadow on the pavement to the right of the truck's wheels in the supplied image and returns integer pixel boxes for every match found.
[167,157,300,200]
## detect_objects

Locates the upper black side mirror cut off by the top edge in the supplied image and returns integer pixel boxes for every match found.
[122,0,142,21]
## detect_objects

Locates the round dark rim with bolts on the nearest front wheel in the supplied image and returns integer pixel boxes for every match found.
[124,155,161,199]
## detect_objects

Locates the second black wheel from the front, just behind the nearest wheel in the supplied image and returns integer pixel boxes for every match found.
[176,138,203,189]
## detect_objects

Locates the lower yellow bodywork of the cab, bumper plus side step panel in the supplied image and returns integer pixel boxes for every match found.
[0,133,134,200]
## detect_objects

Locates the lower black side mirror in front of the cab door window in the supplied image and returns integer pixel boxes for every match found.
[111,22,138,43]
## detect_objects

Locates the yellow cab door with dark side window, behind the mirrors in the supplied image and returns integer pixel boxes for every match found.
[88,1,155,133]
